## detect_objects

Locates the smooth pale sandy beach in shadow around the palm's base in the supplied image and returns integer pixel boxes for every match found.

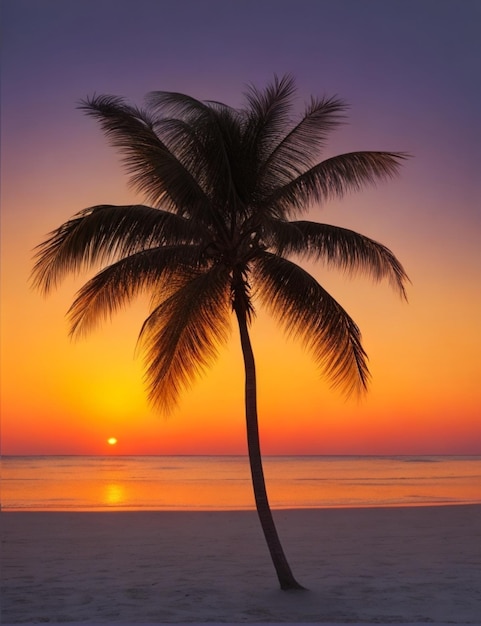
[1,505,481,624]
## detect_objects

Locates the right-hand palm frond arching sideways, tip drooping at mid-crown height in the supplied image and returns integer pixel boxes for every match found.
[267,220,409,299]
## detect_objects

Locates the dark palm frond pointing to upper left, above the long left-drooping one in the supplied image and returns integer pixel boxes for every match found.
[80,96,207,214]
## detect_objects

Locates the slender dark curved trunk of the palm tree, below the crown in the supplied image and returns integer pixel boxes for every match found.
[235,307,304,590]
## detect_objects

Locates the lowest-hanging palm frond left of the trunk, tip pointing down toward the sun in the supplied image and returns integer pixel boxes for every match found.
[139,266,231,412]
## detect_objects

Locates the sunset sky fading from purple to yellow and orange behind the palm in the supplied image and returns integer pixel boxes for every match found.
[1,0,481,454]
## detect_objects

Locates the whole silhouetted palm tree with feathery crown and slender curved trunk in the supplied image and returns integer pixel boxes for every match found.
[34,76,407,589]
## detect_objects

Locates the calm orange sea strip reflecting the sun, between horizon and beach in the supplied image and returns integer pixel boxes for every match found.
[1,456,481,511]
